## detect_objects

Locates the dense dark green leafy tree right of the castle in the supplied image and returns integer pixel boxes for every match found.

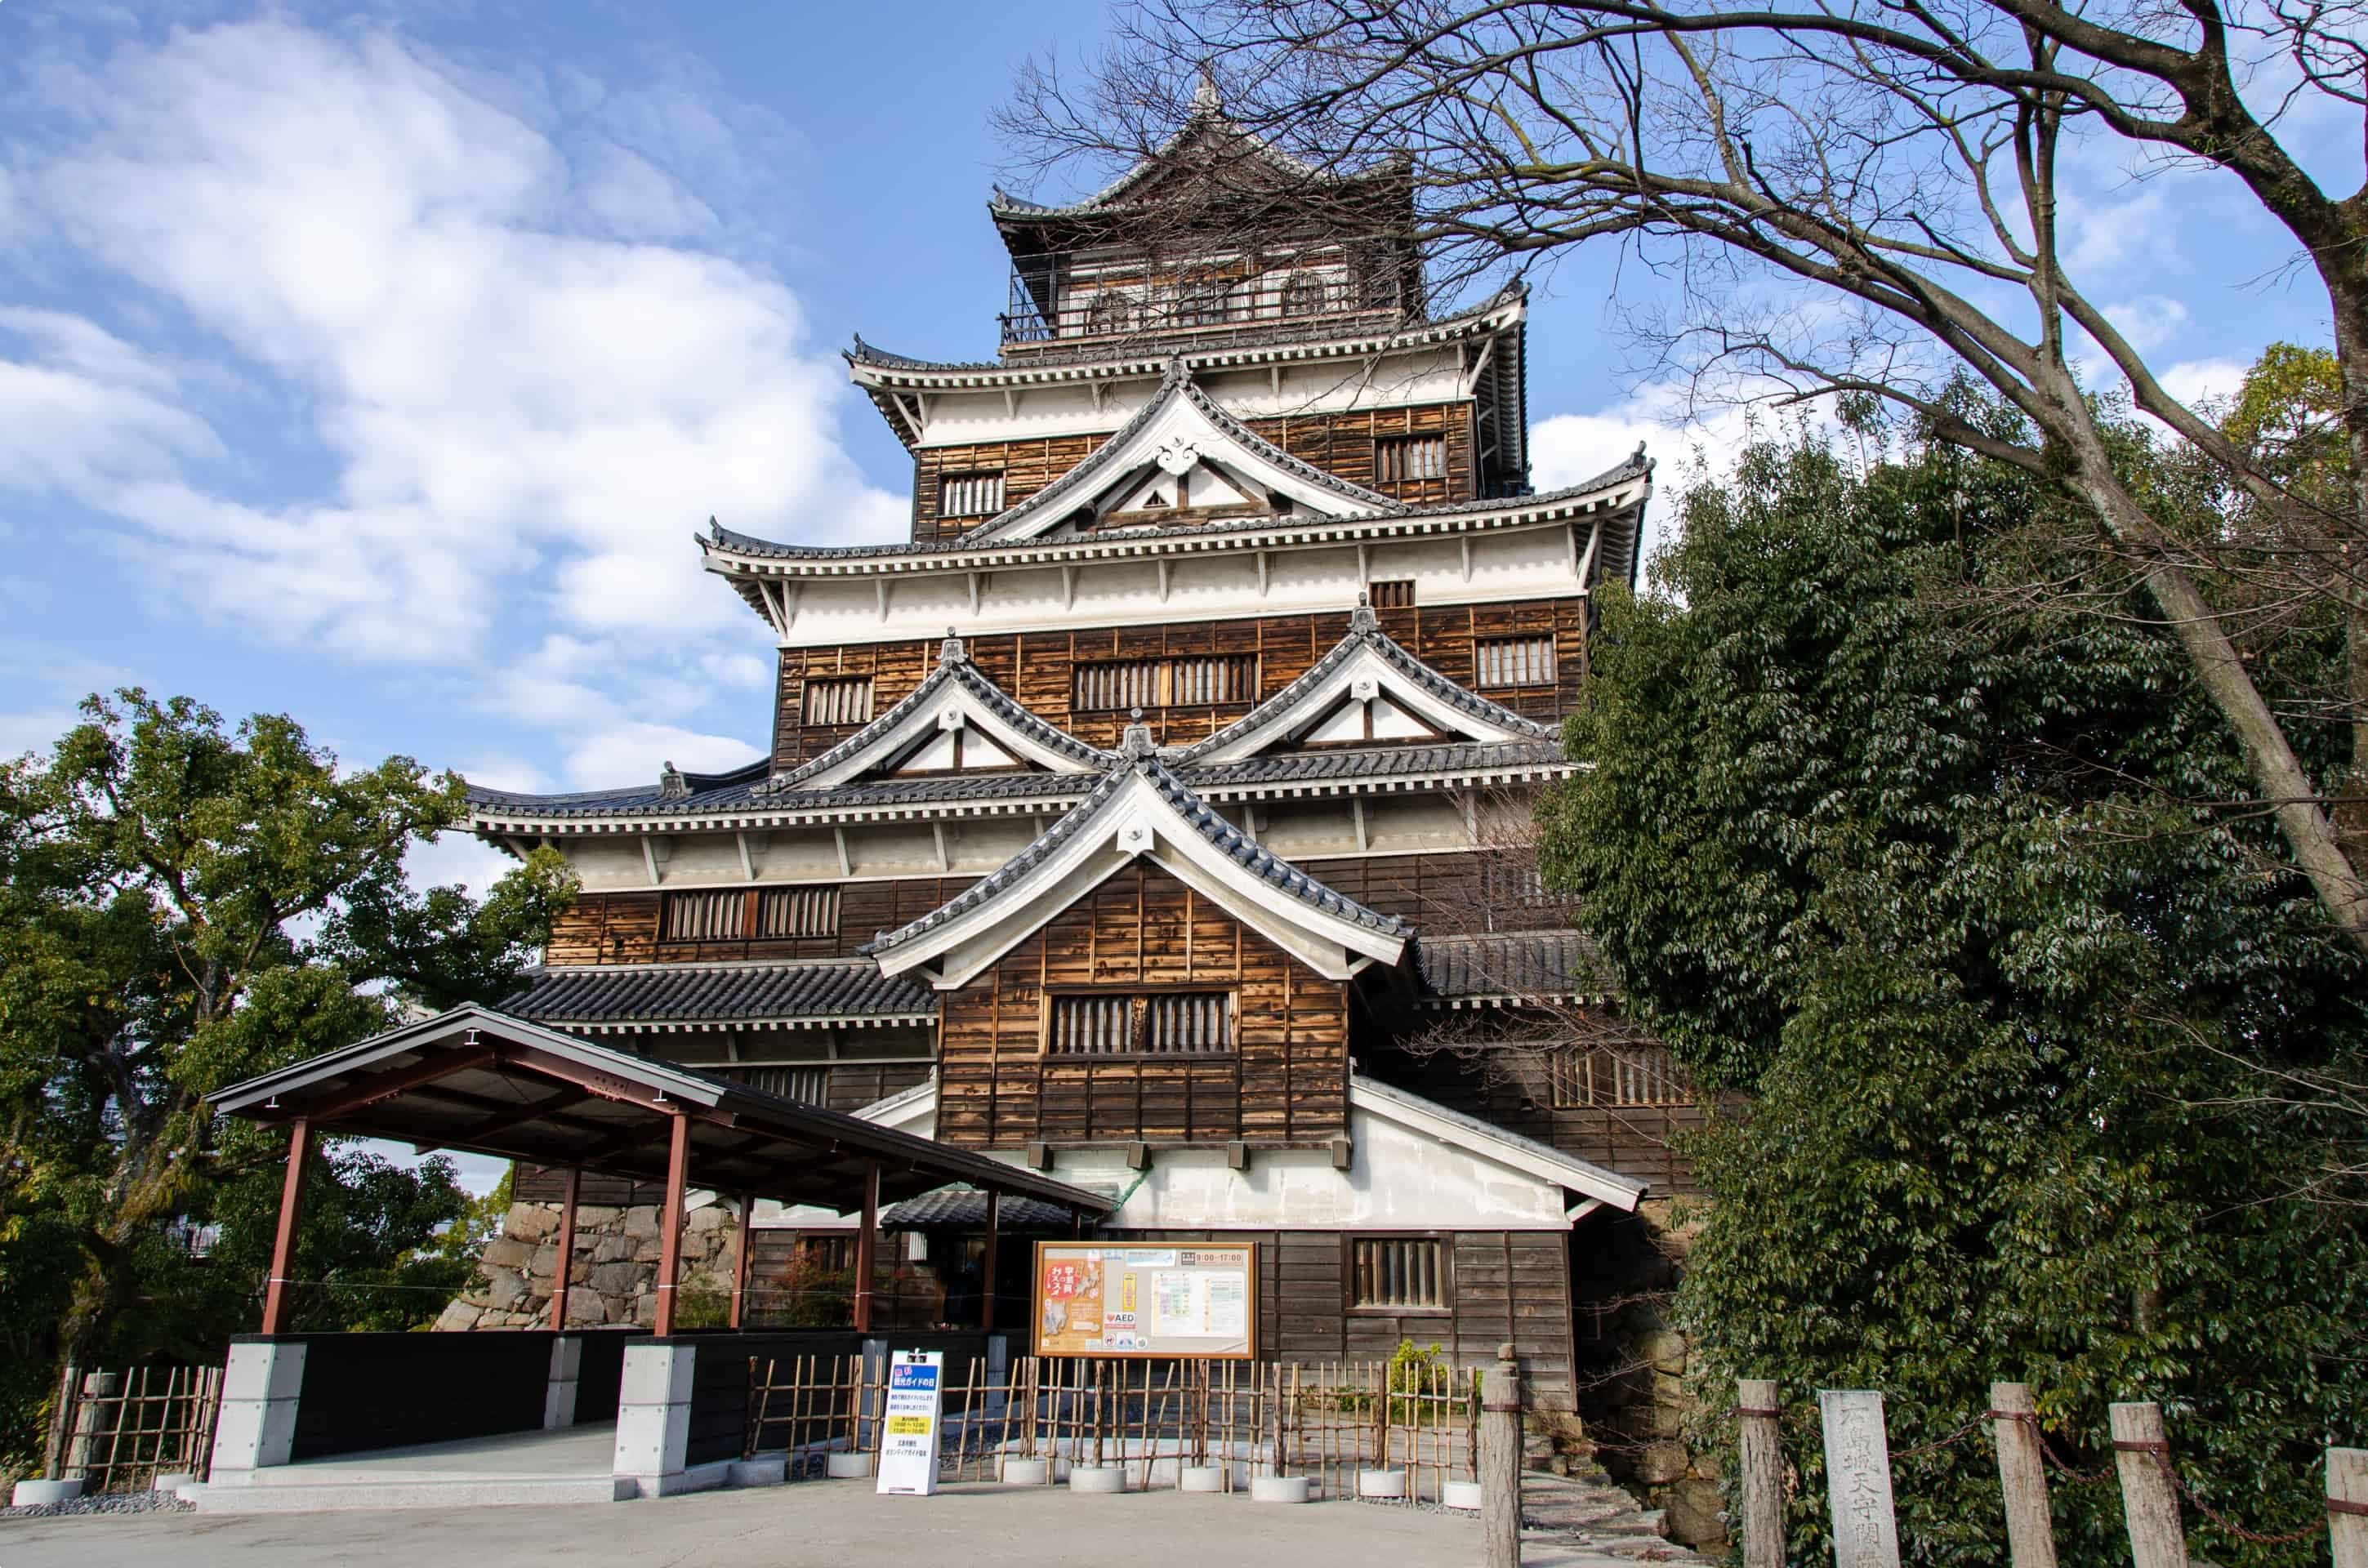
[1544,385,2368,1566]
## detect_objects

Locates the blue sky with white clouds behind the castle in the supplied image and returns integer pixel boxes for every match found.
[0,0,2357,924]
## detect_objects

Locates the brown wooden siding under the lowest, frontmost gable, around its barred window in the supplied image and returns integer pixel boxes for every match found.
[938,860,1348,1149]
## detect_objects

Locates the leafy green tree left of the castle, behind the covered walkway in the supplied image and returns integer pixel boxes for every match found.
[0,692,573,1450]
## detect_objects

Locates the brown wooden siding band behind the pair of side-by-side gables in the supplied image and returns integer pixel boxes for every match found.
[774,599,1586,772]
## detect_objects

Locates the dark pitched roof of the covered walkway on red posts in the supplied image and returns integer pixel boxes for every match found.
[213,1007,1111,1215]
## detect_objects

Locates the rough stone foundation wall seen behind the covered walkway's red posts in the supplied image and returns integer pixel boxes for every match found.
[435,1199,738,1331]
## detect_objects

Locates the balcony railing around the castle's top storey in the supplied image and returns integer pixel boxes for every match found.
[1001,270,1407,348]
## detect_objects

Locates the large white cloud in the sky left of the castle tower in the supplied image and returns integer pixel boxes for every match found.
[0,21,904,777]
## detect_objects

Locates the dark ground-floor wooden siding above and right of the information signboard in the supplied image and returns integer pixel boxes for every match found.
[1096,1229,1572,1410]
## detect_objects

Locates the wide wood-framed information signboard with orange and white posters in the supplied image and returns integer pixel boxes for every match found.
[1035,1241,1257,1360]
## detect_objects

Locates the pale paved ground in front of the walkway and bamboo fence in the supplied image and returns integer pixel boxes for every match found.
[0,1483,1477,1568]
